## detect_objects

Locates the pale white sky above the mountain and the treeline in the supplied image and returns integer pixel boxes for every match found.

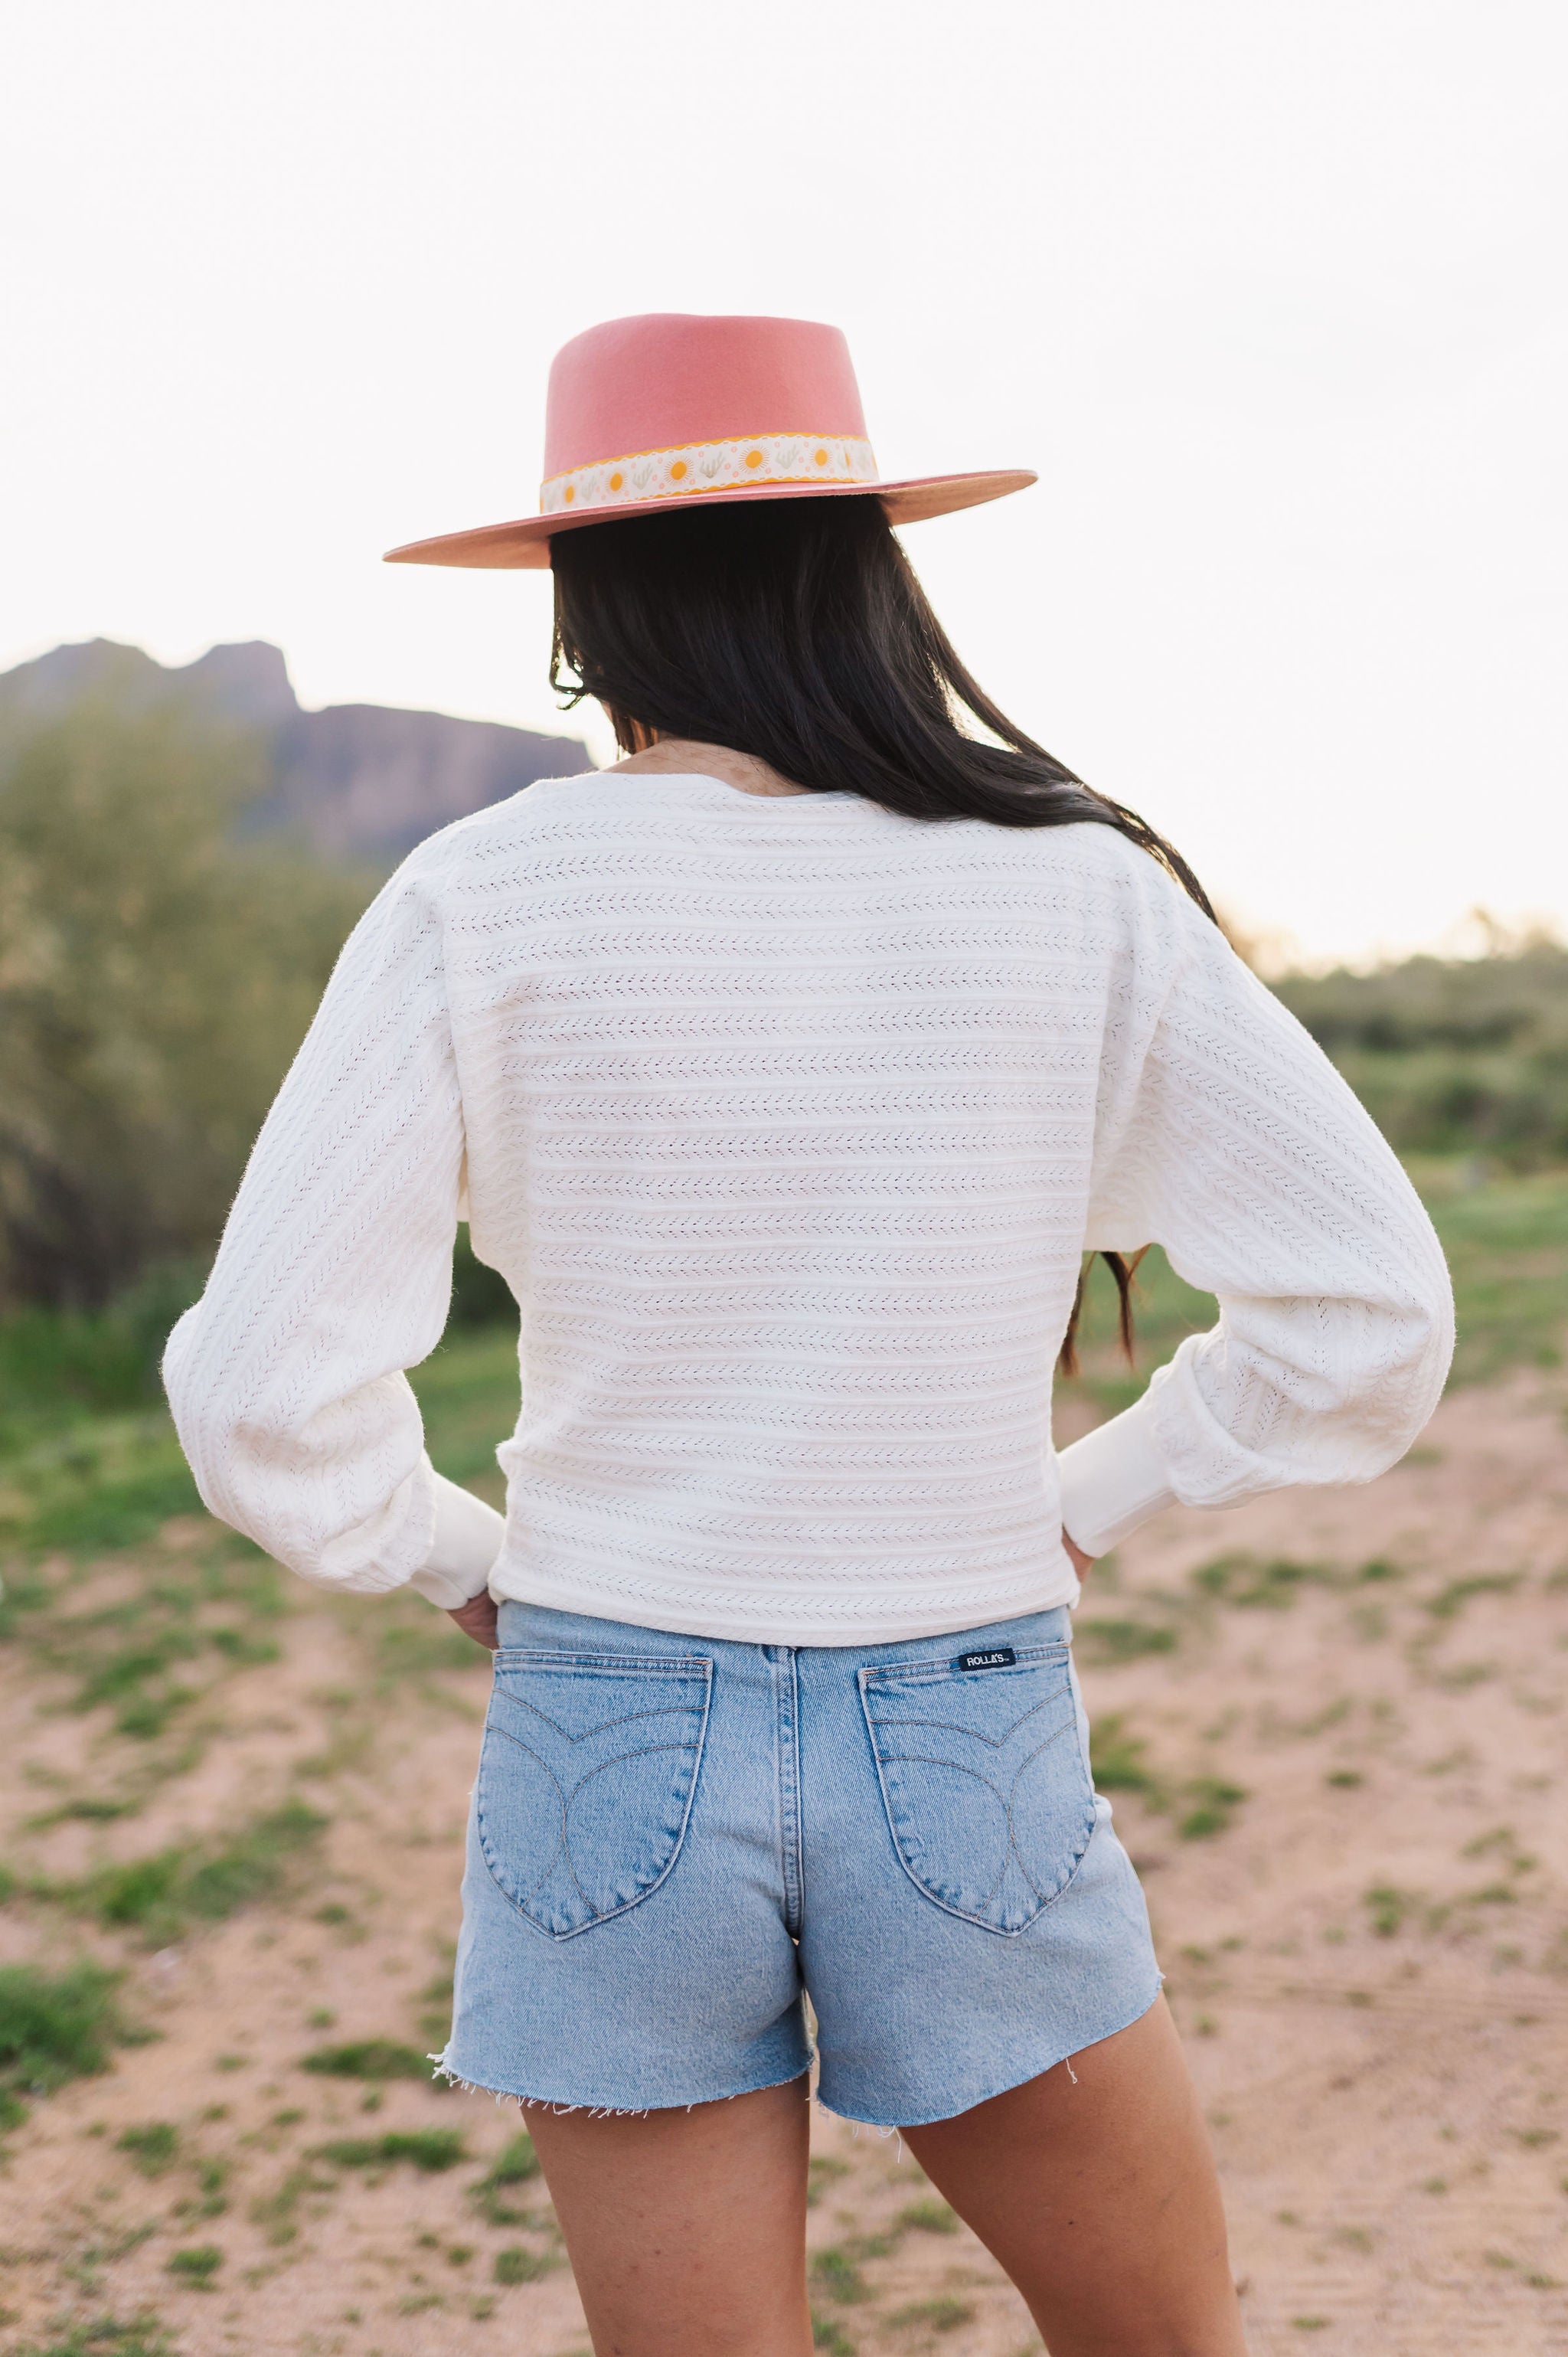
[0,0,1568,959]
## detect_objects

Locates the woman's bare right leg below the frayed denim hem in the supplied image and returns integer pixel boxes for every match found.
[903,1999,1245,2357]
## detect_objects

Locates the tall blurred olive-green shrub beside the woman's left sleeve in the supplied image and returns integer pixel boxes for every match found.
[0,704,368,1319]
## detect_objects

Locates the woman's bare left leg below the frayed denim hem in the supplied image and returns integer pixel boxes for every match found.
[528,2079,811,2357]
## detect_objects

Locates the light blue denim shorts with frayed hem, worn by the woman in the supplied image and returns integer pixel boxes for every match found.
[441,1603,1160,2128]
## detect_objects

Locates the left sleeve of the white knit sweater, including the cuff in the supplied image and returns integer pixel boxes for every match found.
[162,853,505,1605]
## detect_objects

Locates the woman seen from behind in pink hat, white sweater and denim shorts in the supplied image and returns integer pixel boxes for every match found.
[168,319,1450,2357]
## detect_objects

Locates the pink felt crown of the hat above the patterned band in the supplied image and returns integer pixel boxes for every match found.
[544,311,865,479]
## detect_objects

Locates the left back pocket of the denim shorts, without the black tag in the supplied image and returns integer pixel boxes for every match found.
[476,1648,712,1940]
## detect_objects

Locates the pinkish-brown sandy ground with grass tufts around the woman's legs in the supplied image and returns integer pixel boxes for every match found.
[0,1381,1568,2357]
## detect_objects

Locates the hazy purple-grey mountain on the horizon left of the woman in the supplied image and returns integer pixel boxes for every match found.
[0,639,594,865]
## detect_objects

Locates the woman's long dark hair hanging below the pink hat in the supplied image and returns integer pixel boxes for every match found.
[550,495,1214,1374]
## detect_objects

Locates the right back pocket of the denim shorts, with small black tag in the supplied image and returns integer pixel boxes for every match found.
[861,1645,1094,1933]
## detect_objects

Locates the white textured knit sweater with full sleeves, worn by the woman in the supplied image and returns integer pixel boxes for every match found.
[165,773,1452,1645]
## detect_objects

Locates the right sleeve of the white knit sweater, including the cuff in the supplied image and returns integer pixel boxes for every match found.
[1061,870,1452,1553]
